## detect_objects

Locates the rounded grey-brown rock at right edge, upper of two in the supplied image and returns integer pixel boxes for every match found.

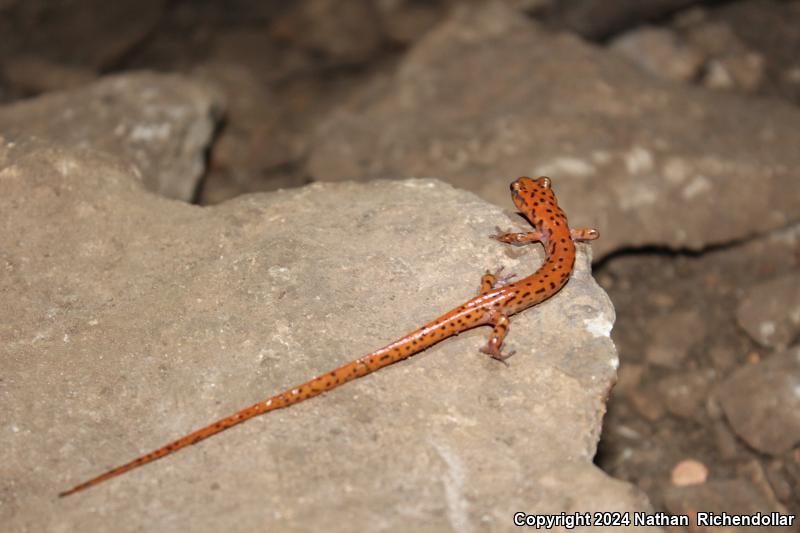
[736,273,800,348]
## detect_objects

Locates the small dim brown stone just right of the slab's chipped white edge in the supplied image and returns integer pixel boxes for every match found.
[645,310,706,369]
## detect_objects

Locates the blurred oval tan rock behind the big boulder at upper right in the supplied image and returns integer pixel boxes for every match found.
[610,26,705,82]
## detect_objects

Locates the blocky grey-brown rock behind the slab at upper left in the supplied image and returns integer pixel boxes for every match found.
[0,72,223,201]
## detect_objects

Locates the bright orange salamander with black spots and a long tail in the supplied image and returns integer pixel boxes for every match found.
[59,177,599,497]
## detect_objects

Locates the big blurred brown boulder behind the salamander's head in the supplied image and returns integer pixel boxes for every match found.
[308,4,800,254]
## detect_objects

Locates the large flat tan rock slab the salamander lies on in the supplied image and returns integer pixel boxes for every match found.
[0,142,647,532]
